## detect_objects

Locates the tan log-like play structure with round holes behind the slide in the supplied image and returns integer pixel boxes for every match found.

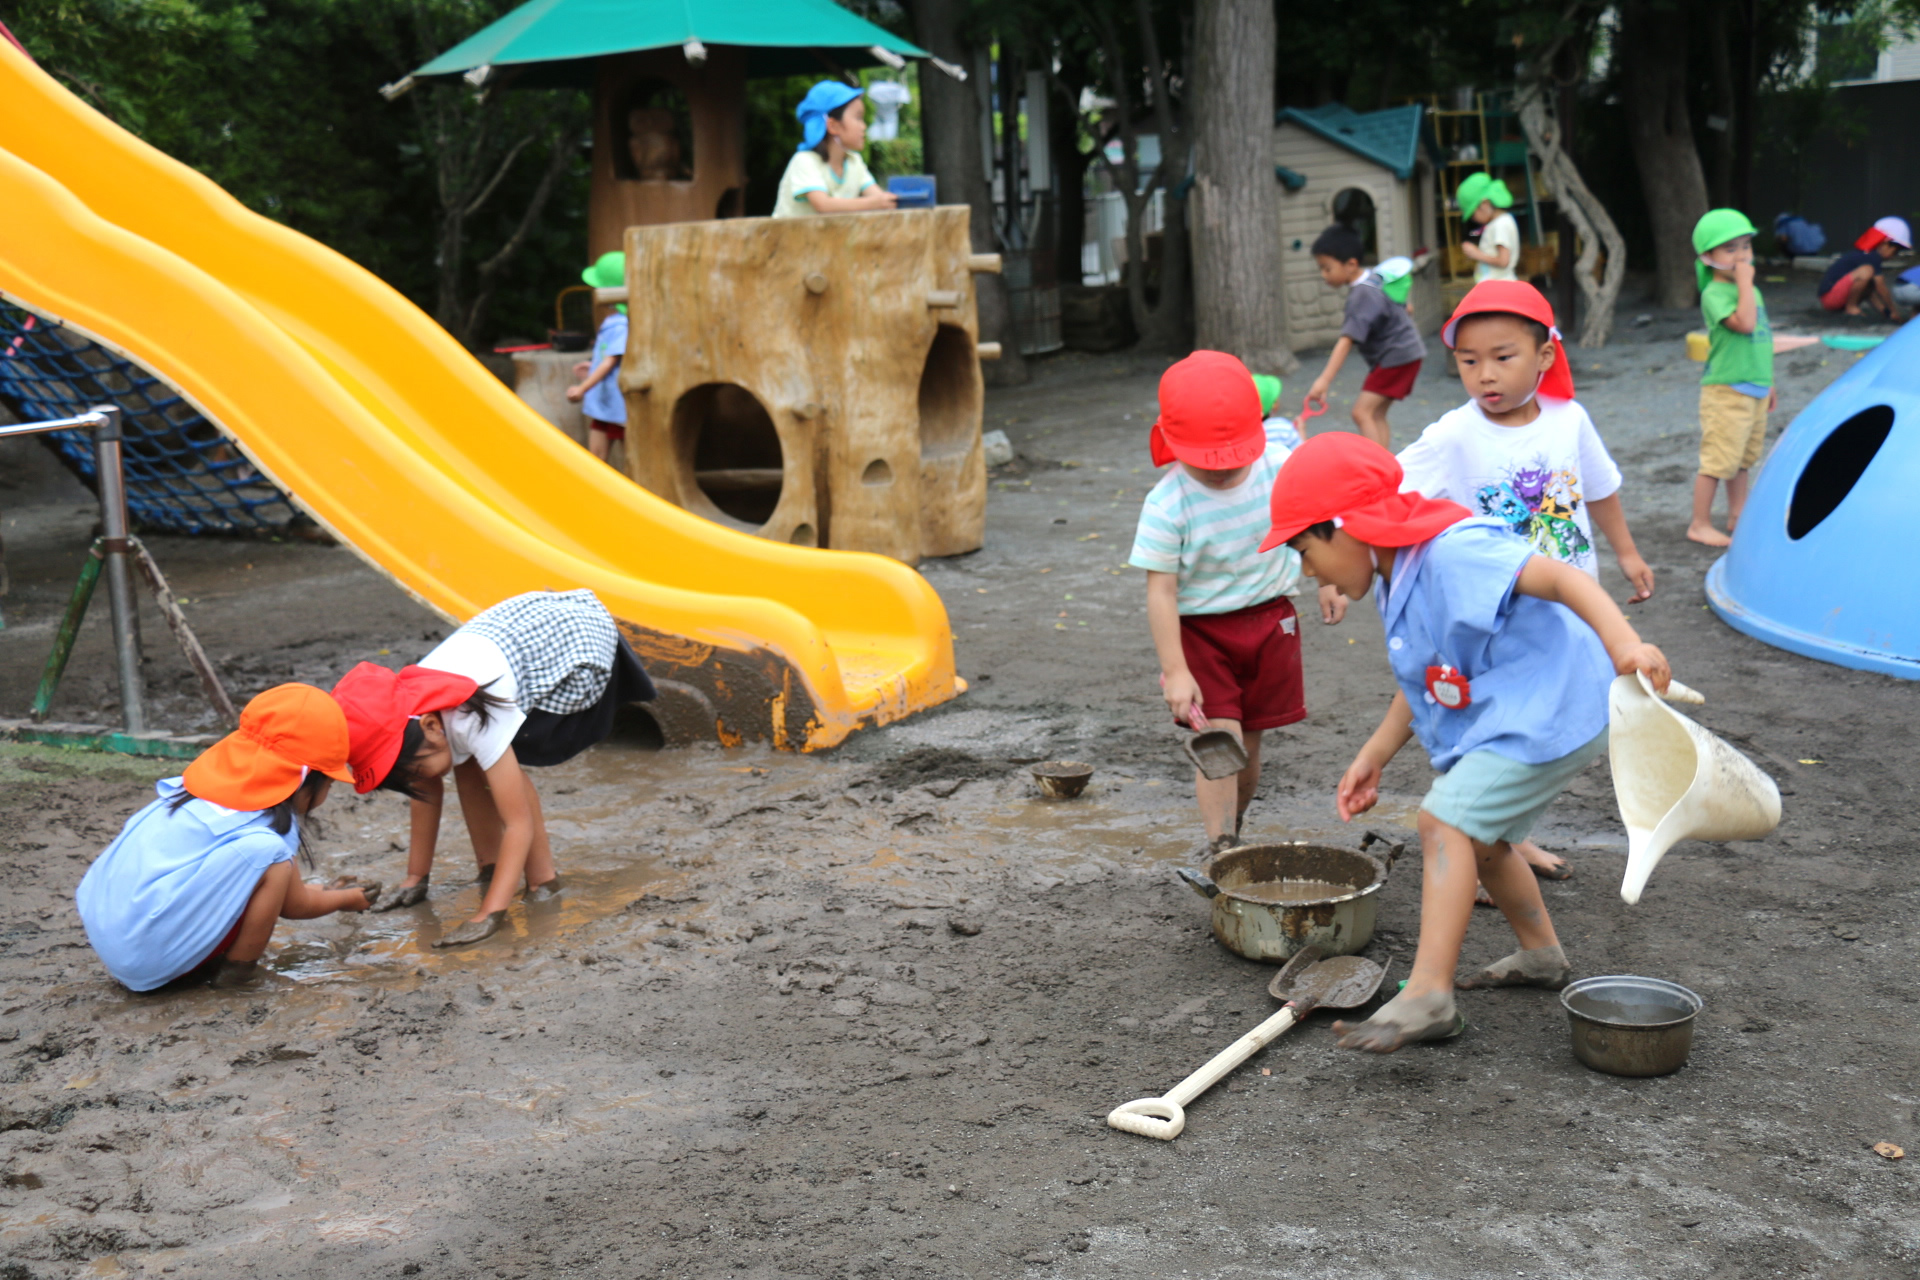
[601,205,1000,564]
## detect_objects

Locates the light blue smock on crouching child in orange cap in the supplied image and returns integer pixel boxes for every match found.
[73,777,300,990]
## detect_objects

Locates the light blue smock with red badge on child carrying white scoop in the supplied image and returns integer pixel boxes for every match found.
[1375,518,1613,771]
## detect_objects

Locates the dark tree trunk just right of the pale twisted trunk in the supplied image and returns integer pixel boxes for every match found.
[1620,0,1707,307]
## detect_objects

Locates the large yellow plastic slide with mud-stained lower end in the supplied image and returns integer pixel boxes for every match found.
[0,40,964,748]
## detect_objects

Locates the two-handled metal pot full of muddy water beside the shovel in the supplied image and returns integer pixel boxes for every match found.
[1181,831,1405,963]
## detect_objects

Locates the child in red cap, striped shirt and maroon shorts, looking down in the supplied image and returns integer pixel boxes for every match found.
[1127,351,1346,852]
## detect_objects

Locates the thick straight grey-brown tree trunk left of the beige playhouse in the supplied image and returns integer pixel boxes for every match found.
[1190,0,1296,372]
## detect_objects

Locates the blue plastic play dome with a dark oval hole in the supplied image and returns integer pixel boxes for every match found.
[1707,324,1920,679]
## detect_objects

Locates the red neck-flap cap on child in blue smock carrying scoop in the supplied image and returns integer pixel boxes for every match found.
[1260,432,1473,551]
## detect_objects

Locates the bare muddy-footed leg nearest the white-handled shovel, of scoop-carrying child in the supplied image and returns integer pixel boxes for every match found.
[1332,810,1466,1054]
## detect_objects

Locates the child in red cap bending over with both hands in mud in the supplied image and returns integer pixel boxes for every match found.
[334,591,653,946]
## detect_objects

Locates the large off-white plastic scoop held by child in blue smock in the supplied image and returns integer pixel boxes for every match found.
[1607,672,1780,904]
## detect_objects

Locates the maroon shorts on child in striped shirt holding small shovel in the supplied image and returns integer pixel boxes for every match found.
[1181,595,1308,729]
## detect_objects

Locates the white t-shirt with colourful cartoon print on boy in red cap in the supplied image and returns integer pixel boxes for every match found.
[1400,397,1620,578]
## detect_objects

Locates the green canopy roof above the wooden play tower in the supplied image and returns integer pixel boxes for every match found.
[413,0,927,88]
